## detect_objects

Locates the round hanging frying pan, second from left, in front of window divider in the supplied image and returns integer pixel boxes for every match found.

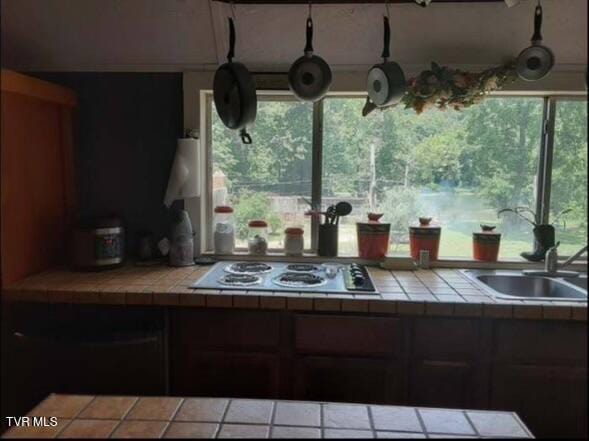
[288,15,331,101]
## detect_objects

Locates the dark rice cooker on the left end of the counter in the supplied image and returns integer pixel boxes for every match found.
[72,217,125,270]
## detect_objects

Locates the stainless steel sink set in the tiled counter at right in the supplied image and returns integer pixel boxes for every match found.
[462,270,587,302]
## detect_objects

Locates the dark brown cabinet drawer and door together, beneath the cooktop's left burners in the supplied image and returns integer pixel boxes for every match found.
[170,308,282,398]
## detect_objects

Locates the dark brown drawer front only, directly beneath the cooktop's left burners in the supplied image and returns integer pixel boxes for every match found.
[170,309,280,351]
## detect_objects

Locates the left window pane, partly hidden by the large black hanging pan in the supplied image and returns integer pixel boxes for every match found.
[208,96,313,250]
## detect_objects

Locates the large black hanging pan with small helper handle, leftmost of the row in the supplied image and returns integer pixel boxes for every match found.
[213,18,258,144]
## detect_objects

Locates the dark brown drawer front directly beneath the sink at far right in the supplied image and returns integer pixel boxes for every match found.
[494,321,587,364]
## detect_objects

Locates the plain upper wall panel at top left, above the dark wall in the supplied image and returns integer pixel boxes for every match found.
[2,0,216,68]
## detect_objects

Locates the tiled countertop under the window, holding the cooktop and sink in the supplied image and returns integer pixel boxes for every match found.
[2,264,587,321]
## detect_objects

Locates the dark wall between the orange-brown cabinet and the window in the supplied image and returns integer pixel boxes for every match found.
[29,72,183,254]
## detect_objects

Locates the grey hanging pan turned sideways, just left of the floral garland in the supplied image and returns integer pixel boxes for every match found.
[367,16,407,107]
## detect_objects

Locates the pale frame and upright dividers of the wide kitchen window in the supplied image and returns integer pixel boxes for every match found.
[200,90,587,261]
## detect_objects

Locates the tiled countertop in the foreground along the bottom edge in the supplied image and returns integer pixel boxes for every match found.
[3,394,533,438]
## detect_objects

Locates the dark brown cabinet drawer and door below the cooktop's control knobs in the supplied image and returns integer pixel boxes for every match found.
[294,314,406,403]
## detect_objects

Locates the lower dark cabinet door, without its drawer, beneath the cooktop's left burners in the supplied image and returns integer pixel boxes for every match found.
[171,351,279,398]
